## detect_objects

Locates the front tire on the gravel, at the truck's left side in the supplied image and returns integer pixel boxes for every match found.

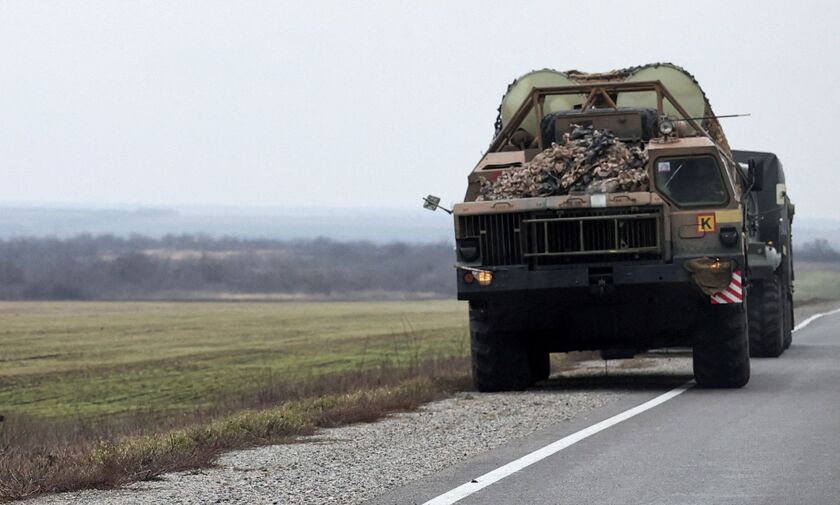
[470,307,534,392]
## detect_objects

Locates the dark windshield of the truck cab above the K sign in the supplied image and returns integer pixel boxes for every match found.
[653,156,728,207]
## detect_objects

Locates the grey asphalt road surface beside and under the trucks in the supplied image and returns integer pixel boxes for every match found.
[373,314,840,505]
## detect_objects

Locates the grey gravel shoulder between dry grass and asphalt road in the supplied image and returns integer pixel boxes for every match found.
[27,391,617,504]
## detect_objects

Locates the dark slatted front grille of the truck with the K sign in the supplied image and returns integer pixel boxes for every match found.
[458,207,662,267]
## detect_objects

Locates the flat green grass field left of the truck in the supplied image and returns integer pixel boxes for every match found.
[0,301,468,417]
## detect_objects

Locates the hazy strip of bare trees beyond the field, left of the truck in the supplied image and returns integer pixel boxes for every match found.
[0,235,455,300]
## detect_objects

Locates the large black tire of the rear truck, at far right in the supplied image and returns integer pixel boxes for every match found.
[749,275,787,358]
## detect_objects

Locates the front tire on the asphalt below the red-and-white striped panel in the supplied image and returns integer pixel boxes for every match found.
[693,303,750,388]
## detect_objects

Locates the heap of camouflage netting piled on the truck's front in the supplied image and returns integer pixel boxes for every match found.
[478,126,649,201]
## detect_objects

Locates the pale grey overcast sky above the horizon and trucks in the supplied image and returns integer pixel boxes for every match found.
[0,0,840,217]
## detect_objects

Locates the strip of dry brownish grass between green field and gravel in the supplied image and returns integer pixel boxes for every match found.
[0,358,469,501]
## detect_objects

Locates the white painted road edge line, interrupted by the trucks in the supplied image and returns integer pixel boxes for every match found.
[423,309,840,505]
